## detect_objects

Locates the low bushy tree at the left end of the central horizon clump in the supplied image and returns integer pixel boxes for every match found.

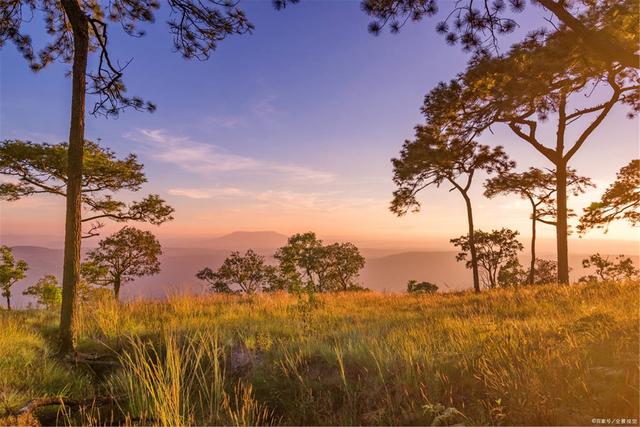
[196,249,277,294]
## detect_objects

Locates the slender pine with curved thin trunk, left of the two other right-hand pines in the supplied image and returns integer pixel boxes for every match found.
[390,126,514,292]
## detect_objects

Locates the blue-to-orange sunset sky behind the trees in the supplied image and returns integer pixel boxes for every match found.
[0,1,640,253]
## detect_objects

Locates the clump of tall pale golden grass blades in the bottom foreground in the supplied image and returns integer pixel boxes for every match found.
[111,332,271,426]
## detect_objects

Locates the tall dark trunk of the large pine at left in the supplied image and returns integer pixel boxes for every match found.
[59,0,89,354]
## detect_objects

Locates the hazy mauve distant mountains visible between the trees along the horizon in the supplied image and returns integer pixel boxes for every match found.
[6,244,638,307]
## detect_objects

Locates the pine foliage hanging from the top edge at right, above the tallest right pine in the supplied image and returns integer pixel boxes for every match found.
[362,0,640,68]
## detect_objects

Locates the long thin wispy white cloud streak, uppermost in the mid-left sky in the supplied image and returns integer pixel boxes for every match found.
[125,129,335,184]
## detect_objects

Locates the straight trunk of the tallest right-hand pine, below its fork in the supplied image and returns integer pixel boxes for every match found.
[556,166,569,284]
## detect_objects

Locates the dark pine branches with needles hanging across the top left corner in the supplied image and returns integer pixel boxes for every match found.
[0,0,253,116]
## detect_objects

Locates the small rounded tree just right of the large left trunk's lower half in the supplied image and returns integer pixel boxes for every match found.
[84,226,162,300]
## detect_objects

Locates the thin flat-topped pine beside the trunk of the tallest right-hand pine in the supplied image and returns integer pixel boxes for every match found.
[484,168,593,285]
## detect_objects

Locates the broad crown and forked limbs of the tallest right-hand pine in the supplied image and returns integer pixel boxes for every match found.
[422,6,640,155]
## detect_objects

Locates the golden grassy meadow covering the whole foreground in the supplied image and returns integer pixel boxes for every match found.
[0,282,640,425]
